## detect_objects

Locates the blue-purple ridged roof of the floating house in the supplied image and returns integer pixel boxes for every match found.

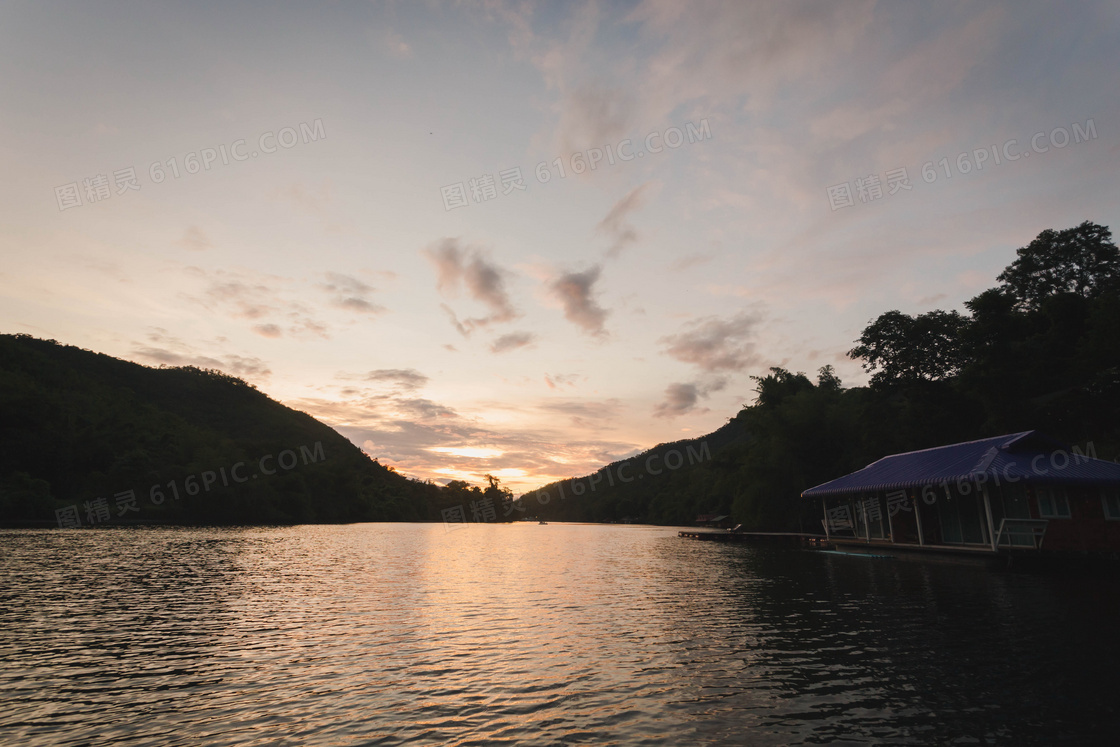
[801,430,1120,497]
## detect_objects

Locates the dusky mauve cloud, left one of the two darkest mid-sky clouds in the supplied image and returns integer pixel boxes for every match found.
[422,239,520,337]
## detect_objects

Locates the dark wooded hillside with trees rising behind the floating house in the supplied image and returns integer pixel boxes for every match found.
[522,222,1120,531]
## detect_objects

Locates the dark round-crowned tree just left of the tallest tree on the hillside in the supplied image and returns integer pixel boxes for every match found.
[848,309,969,387]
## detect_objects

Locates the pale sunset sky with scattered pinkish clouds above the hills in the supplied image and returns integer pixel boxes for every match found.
[0,0,1120,492]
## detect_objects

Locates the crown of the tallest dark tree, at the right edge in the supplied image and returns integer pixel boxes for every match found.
[998,221,1120,311]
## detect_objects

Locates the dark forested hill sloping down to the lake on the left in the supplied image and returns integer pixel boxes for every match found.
[0,335,441,526]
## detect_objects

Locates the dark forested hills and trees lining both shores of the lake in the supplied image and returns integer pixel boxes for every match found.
[8,222,1120,531]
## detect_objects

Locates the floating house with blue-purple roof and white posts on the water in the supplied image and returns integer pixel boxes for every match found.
[802,431,1120,557]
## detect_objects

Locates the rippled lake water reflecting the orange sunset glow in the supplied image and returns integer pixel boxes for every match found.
[0,524,1120,745]
